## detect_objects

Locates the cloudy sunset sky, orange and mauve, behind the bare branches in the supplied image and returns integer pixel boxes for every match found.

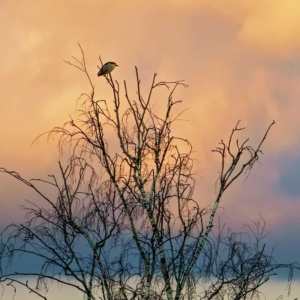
[0,0,300,300]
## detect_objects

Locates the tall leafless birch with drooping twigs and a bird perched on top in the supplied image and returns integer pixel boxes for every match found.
[0,47,292,300]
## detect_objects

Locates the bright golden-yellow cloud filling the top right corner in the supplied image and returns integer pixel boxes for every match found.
[238,0,300,59]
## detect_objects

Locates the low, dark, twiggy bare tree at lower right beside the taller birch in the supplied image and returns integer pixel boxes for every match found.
[196,215,296,300]
